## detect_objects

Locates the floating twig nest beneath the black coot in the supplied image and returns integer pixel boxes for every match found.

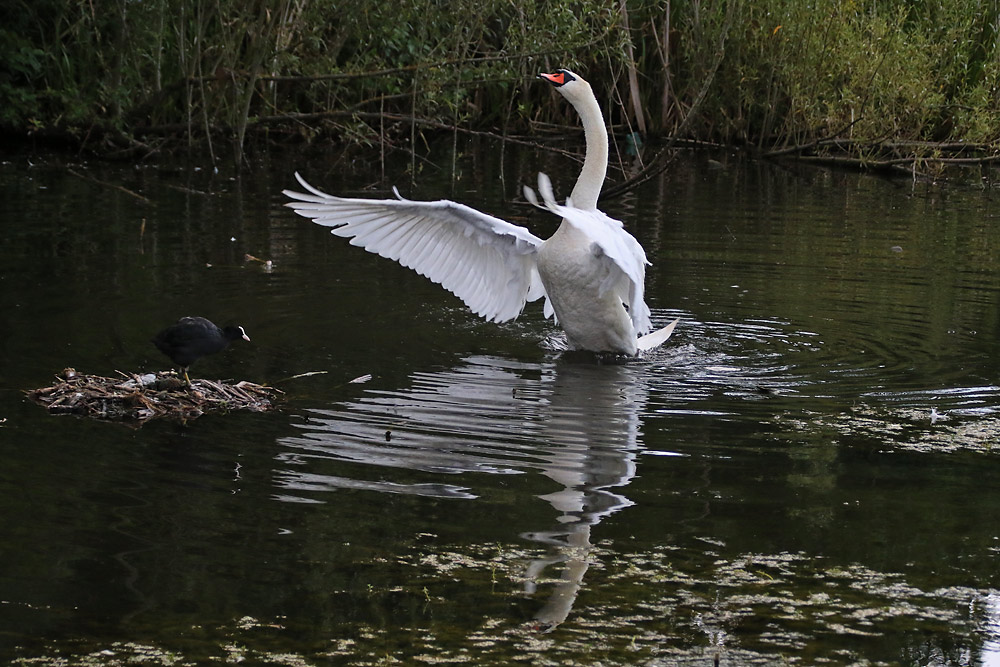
[27,368,282,422]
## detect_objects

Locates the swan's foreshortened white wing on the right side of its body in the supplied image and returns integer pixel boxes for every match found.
[524,174,652,335]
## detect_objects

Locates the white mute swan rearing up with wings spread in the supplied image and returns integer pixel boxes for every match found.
[283,69,677,356]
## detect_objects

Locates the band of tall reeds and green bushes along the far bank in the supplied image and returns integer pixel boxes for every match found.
[0,0,1000,162]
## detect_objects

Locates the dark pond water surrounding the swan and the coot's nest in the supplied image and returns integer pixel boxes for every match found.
[0,146,1000,665]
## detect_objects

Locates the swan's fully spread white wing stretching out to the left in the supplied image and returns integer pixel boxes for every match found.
[284,173,545,322]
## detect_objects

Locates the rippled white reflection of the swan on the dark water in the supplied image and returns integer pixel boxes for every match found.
[278,356,650,631]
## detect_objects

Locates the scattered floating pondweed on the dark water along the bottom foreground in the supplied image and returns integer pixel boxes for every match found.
[17,544,1000,665]
